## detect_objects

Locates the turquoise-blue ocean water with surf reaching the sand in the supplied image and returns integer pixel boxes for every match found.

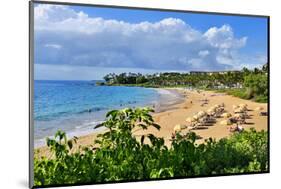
[34,80,182,147]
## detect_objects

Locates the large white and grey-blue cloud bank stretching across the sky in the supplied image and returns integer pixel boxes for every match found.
[35,5,264,70]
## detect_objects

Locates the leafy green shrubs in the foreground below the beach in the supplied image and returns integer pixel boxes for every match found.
[34,108,268,186]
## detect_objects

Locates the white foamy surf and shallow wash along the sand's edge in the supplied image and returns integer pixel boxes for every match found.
[34,86,185,149]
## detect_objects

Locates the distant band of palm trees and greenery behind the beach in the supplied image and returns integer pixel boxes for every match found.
[102,64,268,102]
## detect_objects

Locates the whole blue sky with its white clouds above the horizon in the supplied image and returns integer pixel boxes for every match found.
[34,4,267,80]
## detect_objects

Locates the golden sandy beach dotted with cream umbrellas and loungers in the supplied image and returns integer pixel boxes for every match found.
[36,88,268,158]
